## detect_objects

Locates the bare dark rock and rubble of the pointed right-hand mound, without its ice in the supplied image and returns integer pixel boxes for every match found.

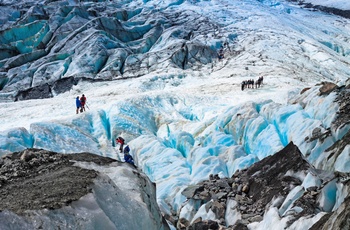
[173,141,350,229]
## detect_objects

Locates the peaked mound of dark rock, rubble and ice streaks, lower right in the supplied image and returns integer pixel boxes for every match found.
[177,143,350,229]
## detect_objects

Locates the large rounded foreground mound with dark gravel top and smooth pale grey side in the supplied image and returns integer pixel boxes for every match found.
[0,149,169,229]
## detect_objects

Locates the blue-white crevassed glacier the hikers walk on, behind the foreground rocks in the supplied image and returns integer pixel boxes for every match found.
[0,0,350,229]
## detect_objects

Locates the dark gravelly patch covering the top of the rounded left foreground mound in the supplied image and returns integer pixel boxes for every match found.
[0,149,98,214]
